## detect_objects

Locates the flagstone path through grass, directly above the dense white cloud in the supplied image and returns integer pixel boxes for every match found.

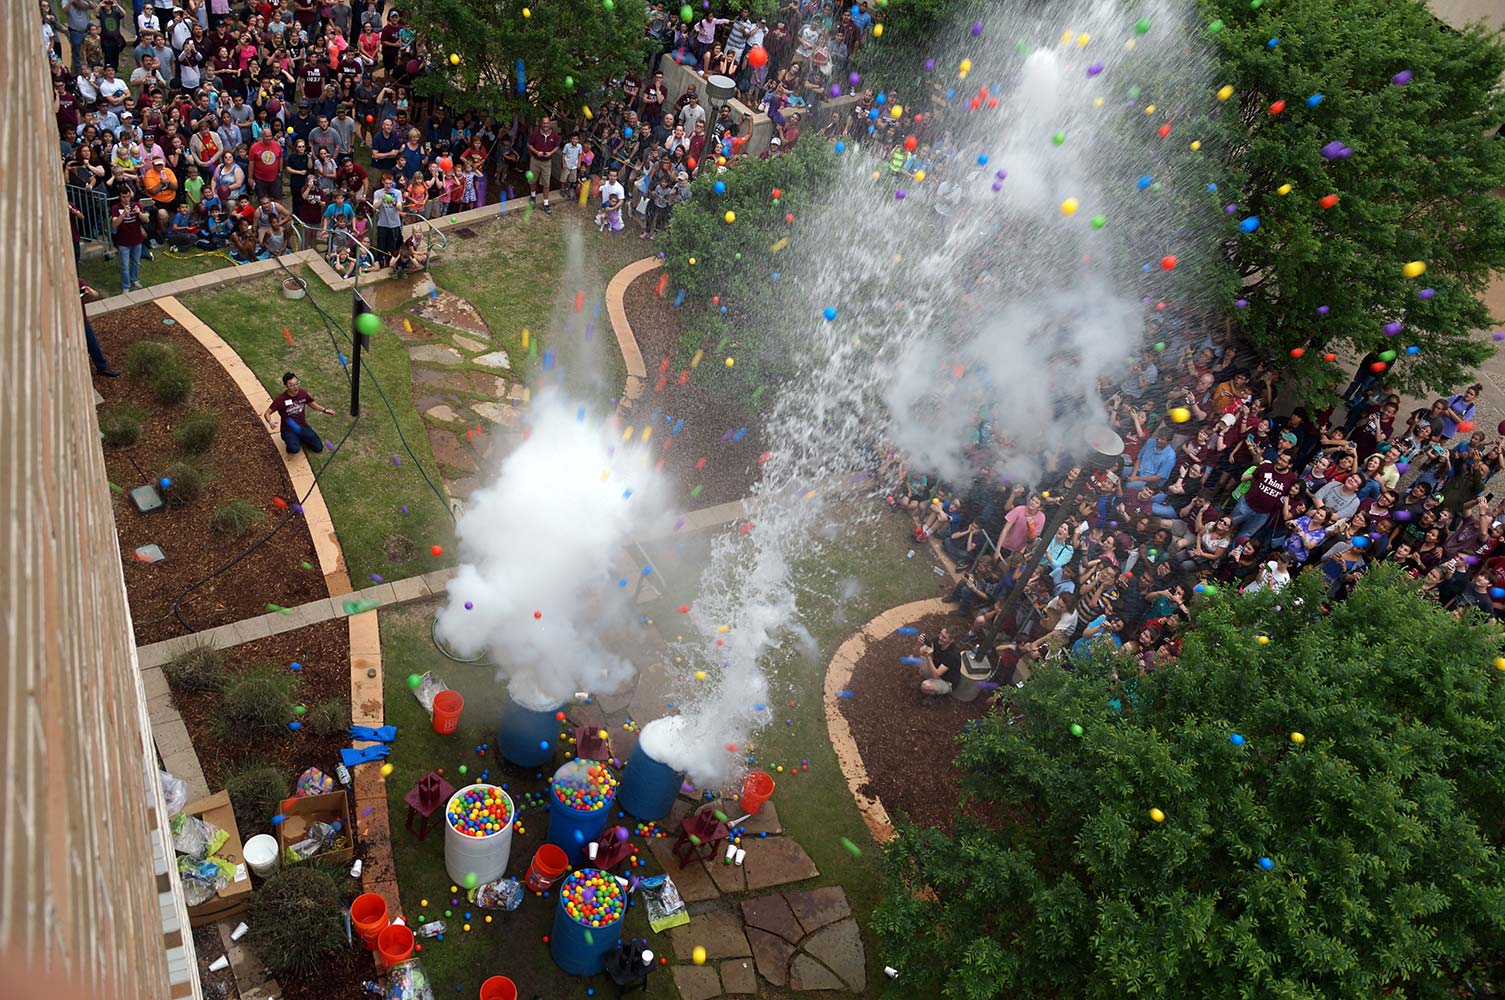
[397,283,528,502]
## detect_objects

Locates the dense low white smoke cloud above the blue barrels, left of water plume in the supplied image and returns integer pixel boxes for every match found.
[438,392,667,709]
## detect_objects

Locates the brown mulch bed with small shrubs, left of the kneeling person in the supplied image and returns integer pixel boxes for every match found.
[93,304,328,645]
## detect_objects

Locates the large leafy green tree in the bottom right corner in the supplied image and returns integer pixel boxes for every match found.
[874,568,1505,1000]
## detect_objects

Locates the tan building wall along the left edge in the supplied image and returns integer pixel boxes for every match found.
[0,0,186,1000]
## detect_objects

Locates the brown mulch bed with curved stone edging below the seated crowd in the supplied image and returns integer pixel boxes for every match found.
[840,614,989,833]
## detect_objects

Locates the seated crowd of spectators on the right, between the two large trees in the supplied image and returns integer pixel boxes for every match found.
[885,330,1505,694]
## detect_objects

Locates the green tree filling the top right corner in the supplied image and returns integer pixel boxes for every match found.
[1189,0,1505,393]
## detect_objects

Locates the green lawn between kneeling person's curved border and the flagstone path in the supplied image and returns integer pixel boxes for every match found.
[182,273,455,589]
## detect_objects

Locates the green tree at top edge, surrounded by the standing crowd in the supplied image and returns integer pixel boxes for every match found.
[402,0,653,122]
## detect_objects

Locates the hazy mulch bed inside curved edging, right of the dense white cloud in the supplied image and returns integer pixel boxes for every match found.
[622,270,768,509]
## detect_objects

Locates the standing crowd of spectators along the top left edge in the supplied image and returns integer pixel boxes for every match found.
[50,0,873,291]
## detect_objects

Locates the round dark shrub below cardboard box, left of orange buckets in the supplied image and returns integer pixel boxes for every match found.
[248,863,345,977]
